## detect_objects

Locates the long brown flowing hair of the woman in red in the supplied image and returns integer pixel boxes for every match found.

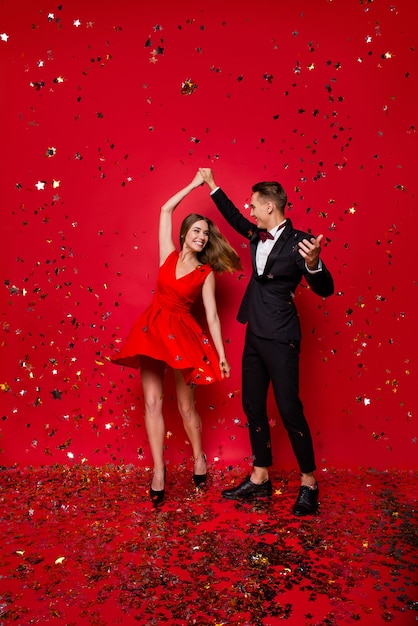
[180,213,242,274]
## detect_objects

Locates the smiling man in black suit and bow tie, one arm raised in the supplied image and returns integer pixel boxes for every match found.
[199,168,334,516]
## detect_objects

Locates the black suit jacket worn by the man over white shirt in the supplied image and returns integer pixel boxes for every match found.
[212,188,334,343]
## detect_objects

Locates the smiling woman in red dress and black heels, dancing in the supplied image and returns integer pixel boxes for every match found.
[112,173,242,505]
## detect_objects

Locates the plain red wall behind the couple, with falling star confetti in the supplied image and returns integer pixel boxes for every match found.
[0,0,418,470]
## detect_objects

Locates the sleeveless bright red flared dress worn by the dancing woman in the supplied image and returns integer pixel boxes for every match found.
[112,250,222,385]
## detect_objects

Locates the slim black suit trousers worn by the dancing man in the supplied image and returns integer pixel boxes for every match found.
[242,326,315,474]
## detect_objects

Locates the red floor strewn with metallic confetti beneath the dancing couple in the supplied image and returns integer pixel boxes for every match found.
[0,466,418,626]
